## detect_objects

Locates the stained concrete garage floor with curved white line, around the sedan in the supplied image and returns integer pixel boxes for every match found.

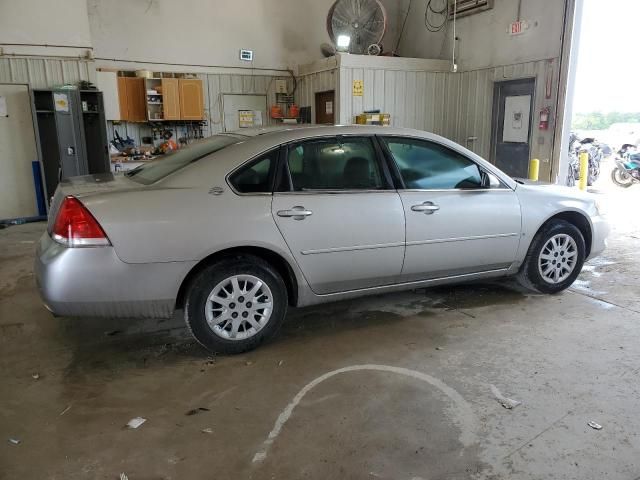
[0,162,640,480]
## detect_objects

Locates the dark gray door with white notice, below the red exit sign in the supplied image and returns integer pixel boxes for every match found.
[491,79,535,177]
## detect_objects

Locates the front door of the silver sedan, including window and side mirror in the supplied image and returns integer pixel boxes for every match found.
[382,137,521,281]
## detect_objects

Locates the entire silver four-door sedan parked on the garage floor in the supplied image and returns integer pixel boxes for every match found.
[36,127,608,353]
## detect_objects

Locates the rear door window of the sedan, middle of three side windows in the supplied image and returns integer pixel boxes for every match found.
[287,138,384,192]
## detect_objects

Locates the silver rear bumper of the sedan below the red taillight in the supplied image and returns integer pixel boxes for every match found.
[34,233,195,318]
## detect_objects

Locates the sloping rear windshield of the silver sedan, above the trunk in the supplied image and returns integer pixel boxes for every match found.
[125,135,246,185]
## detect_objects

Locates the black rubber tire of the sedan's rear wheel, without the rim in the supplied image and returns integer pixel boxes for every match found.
[184,255,288,354]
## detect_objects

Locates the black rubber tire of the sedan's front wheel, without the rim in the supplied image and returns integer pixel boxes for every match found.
[517,220,586,294]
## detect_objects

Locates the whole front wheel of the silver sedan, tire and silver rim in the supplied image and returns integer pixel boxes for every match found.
[518,220,586,293]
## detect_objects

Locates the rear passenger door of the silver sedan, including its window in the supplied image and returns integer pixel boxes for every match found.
[272,136,404,294]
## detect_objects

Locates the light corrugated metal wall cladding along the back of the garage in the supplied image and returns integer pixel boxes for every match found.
[0,57,558,178]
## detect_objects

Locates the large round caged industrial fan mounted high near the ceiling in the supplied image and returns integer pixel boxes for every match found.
[327,0,387,55]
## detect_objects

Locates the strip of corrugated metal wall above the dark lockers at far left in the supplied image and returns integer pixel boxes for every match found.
[0,57,96,88]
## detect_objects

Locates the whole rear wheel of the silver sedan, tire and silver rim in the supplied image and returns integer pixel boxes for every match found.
[184,255,288,354]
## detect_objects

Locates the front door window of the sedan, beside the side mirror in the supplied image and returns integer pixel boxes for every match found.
[383,137,482,190]
